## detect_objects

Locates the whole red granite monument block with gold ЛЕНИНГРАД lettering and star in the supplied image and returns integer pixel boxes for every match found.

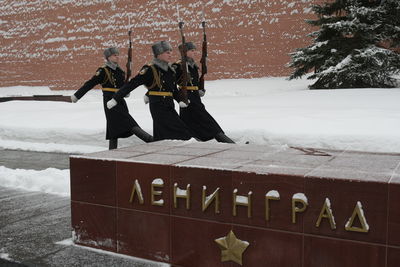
[70,141,400,267]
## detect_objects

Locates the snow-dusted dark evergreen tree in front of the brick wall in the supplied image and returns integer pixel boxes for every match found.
[289,0,400,89]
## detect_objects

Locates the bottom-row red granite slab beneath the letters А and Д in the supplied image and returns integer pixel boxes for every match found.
[303,236,386,267]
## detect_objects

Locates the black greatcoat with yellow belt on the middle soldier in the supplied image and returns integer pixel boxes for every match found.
[114,63,192,141]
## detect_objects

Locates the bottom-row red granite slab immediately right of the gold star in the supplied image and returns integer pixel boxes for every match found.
[233,225,304,267]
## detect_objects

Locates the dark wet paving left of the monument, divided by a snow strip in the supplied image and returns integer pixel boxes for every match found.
[0,150,169,267]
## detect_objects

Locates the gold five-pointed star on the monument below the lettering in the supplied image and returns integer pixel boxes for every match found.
[215,230,249,265]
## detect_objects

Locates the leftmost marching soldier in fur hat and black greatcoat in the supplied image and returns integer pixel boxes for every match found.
[71,47,153,149]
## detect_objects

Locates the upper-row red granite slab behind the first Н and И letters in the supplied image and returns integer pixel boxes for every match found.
[170,166,232,222]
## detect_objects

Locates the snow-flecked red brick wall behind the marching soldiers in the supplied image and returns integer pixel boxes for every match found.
[0,0,316,89]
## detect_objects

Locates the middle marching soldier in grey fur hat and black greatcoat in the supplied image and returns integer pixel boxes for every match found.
[107,41,192,141]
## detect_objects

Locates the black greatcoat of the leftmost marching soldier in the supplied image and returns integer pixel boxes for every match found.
[75,66,138,140]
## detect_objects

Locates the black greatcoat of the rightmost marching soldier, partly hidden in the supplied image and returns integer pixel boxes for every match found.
[173,61,224,141]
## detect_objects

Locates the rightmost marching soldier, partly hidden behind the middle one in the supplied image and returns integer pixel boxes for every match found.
[173,42,234,143]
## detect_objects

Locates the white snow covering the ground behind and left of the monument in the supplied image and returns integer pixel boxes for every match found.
[0,78,400,195]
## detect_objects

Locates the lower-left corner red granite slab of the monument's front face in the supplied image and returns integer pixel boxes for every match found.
[71,201,117,252]
